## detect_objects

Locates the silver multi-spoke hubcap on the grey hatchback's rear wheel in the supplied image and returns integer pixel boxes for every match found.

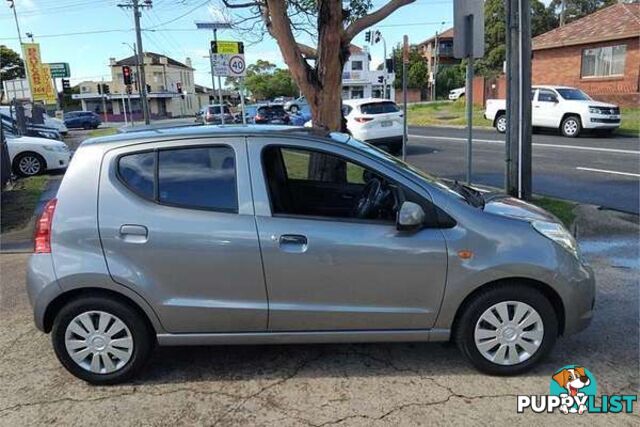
[64,311,133,374]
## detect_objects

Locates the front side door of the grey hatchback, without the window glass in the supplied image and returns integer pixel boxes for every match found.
[248,138,447,331]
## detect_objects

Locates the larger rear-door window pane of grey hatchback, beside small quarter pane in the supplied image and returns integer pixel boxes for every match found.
[158,146,238,212]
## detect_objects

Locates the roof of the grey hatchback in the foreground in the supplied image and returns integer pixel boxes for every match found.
[82,125,317,145]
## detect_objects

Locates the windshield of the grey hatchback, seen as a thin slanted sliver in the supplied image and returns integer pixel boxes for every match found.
[336,132,484,209]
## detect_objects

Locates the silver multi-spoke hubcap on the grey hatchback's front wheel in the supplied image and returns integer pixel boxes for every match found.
[473,301,544,365]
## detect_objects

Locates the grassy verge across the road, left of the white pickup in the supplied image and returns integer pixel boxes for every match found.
[407,99,491,127]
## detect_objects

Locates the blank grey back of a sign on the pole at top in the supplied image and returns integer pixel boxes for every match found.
[453,0,484,59]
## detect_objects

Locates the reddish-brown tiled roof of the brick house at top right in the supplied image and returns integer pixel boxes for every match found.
[532,3,640,50]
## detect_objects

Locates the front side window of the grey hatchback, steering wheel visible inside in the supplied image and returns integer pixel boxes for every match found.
[262,146,410,223]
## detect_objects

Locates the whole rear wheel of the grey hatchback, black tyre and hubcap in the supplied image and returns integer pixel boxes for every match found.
[51,296,155,384]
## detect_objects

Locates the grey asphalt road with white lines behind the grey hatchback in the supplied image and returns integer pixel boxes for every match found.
[407,127,640,214]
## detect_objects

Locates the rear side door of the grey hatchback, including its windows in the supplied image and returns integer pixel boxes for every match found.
[98,138,268,333]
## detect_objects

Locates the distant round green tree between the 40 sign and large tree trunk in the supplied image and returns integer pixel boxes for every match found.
[226,59,299,100]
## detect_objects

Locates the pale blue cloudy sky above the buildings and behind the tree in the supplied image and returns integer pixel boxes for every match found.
[0,0,453,87]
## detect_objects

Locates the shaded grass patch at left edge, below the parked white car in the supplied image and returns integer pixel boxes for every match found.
[0,176,49,233]
